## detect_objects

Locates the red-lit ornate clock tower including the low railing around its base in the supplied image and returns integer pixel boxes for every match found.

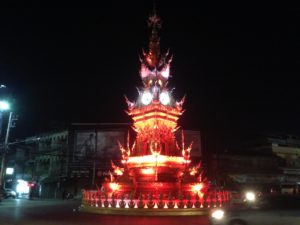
[79,9,228,214]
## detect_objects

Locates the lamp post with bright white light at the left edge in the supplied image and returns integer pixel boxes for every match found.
[0,101,12,188]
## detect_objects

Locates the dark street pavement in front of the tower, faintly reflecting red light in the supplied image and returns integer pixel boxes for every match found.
[0,199,208,225]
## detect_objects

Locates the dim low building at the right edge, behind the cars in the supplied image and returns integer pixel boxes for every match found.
[210,135,300,191]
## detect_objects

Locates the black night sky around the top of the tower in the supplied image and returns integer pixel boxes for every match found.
[0,3,300,148]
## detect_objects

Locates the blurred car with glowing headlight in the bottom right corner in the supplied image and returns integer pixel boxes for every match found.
[209,194,300,225]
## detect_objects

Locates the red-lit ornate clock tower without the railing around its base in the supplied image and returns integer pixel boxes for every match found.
[103,10,206,196]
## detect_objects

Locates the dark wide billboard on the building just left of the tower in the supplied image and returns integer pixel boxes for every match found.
[73,130,125,161]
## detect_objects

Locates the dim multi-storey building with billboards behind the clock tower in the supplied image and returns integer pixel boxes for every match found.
[5,123,201,198]
